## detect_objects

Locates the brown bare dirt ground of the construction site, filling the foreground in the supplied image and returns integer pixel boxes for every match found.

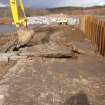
[0,25,105,105]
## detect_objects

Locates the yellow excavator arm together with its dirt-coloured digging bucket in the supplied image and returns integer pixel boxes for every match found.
[9,0,33,47]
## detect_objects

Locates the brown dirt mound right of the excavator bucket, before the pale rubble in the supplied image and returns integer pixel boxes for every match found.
[30,25,85,44]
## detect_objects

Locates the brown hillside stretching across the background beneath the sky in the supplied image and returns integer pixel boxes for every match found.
[0,6,105,17]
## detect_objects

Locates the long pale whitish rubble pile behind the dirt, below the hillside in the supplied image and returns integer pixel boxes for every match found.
[27,15,80,26]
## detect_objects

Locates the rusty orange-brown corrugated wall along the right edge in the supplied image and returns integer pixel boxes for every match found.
[80,16,105,56]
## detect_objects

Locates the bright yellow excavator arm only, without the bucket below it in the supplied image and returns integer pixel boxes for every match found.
[9,0,27,28]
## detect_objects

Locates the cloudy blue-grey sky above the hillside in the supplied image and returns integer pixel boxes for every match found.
[0,0,105,8]
